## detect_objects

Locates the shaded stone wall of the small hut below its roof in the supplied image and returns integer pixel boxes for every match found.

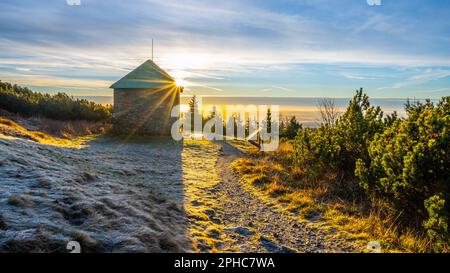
[113,88,180,136]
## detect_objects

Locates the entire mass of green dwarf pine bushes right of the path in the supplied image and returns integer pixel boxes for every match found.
[292,90,450,250]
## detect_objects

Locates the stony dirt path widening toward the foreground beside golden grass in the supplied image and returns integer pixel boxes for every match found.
[213,143,356,253]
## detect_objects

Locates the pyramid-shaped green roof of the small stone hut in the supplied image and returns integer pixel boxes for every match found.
[111,60,175,89]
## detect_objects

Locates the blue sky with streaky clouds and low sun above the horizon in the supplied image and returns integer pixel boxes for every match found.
[0,0,450,98]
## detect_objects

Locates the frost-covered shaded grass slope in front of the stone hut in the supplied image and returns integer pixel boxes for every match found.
[0,130,192,252]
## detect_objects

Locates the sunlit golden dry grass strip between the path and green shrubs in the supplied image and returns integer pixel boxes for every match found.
[232,144,431,252]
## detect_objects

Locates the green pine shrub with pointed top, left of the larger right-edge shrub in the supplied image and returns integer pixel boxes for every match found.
[293,89,390,180]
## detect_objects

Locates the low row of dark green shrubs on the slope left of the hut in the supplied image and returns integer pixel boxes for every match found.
[0,81,112,121]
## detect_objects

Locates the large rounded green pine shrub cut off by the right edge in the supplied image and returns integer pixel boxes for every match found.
[355,97,450,242]
